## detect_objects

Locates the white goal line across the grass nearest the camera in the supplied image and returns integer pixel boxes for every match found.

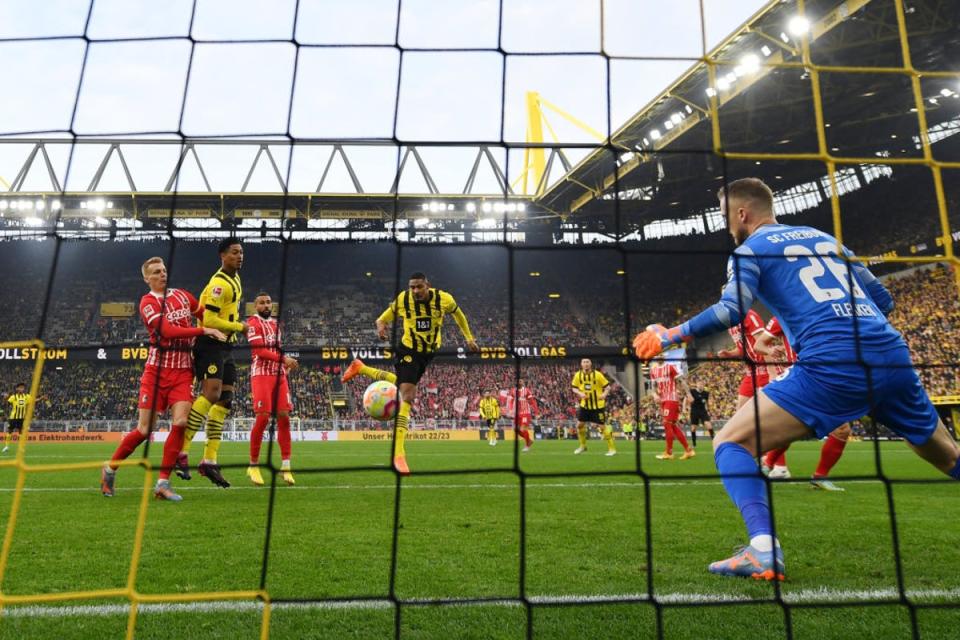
[2,587,960,618]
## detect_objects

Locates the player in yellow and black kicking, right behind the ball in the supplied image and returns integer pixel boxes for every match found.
[342,271,480,475]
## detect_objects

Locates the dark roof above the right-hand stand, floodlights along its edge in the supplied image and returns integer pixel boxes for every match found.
[537,0,960,221]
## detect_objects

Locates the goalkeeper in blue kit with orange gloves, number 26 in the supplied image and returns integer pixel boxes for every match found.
[633,178,960,580]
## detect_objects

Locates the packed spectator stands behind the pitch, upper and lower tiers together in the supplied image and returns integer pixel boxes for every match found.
[0,169,960,430]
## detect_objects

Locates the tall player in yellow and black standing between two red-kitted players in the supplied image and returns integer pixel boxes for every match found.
[176,238,247,489]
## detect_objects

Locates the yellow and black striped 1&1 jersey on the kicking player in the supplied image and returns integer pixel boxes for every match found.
[377,288,473,353]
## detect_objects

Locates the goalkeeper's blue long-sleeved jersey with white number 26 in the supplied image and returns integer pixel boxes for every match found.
[683,224,905,360]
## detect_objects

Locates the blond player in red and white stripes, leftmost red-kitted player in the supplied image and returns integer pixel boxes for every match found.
[100,257,223,501]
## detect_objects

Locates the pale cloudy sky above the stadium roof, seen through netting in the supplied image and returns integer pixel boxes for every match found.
[0,0,764,192]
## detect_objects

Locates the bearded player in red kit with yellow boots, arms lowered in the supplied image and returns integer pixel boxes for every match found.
[247,292,298,485]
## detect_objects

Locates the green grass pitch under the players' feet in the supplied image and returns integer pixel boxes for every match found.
[0,440,960,640]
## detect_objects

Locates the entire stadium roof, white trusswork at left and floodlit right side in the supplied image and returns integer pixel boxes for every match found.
[0,0,960,237]
